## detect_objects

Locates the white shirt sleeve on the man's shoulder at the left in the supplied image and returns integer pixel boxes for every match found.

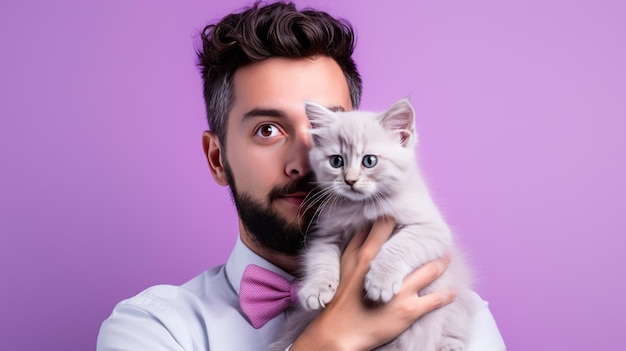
[96,291,192,351]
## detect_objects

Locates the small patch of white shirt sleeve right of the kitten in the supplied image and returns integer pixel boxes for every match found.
[467,293,506,351]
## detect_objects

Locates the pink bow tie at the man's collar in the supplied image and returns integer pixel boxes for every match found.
[239,264,297,329]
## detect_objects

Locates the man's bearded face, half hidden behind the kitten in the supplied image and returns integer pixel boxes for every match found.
[222,56,352,255]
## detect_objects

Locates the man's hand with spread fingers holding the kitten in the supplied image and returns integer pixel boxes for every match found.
[291,218,455,351]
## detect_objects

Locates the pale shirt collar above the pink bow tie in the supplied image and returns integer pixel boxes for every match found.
[226,236,294,295]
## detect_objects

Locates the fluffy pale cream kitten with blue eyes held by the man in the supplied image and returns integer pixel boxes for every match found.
[272,99,473,351]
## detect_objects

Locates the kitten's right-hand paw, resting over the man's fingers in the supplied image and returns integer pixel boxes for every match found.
[365,260,404,302]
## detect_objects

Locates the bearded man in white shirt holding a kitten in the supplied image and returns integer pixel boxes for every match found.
[98,3,504,351]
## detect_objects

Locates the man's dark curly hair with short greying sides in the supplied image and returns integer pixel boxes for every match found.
[197,1,362,147]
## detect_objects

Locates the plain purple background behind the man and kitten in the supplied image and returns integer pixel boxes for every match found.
[0,0,626,350]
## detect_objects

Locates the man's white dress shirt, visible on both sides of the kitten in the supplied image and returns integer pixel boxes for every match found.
[97,239,505,351]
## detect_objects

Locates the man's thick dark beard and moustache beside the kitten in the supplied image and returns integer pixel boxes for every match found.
[224,163,316,256]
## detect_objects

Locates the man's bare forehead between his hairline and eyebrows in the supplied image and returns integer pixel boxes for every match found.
[231,56,352,116]
